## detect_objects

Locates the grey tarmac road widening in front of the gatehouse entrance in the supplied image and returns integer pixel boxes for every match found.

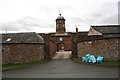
[2,59,118,78]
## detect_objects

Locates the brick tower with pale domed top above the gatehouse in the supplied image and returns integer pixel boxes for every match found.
[56,14,66,34]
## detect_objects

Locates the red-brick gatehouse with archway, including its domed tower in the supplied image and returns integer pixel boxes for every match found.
[44,14,77,58]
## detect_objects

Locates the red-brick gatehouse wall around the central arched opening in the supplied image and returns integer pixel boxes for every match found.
[48,36,71,57]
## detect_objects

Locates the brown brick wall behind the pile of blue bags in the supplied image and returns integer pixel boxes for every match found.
[77,39,120,60]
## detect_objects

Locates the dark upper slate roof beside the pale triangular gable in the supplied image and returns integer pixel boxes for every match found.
[91,25,120,34]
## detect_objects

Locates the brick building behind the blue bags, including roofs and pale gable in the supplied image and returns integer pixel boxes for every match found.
[78,25,120,60]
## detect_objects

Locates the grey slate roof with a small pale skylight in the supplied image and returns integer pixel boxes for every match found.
[2,32,44,43]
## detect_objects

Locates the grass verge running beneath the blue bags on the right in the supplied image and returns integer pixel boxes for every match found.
[72,57,120,67]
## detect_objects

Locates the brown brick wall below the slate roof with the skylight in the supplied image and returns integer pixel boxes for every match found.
[2,43,44,64]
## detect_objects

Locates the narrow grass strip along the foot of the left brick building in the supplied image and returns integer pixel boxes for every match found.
[2,59,48,71]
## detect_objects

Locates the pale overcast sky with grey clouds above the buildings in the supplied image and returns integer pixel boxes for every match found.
[0,0,119,33]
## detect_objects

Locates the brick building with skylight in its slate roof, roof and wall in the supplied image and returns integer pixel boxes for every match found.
[2,32,44,64]
